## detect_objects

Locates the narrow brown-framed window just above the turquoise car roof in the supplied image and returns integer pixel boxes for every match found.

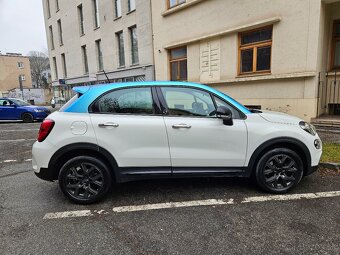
[170,46,188,81]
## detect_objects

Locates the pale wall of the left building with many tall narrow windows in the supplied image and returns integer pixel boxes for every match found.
[42,0,154,89]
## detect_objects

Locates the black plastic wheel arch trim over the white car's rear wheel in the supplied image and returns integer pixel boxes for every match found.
[48,143,118,180]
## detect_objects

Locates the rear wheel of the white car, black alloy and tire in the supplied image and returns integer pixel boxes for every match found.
[58,156,112,204]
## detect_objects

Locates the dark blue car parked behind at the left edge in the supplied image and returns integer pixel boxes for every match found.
[0,98,51,122]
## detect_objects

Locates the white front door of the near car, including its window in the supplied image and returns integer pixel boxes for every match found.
[158,87,247,174]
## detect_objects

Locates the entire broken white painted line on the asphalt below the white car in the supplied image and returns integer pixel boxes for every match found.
[44,191,340,219]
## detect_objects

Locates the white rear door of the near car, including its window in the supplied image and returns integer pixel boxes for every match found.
[90,87,171,175]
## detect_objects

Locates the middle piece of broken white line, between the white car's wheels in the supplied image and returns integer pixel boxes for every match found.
[112,199,234,212]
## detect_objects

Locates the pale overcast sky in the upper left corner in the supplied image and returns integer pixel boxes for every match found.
[0,0,47,55]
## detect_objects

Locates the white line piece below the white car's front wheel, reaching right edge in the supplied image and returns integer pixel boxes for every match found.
[241,191,340,203]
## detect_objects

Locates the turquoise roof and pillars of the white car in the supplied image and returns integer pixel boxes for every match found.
[64,81,251,114]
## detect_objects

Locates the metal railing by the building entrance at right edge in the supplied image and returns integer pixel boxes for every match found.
[317,71,340,116]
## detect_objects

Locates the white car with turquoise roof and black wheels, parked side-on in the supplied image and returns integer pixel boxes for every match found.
[32,82,322,204]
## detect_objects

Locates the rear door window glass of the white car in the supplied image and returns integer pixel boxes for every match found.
[92,87,154,114]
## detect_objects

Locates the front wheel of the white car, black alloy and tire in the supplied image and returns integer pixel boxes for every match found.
[255,148,303,194]
